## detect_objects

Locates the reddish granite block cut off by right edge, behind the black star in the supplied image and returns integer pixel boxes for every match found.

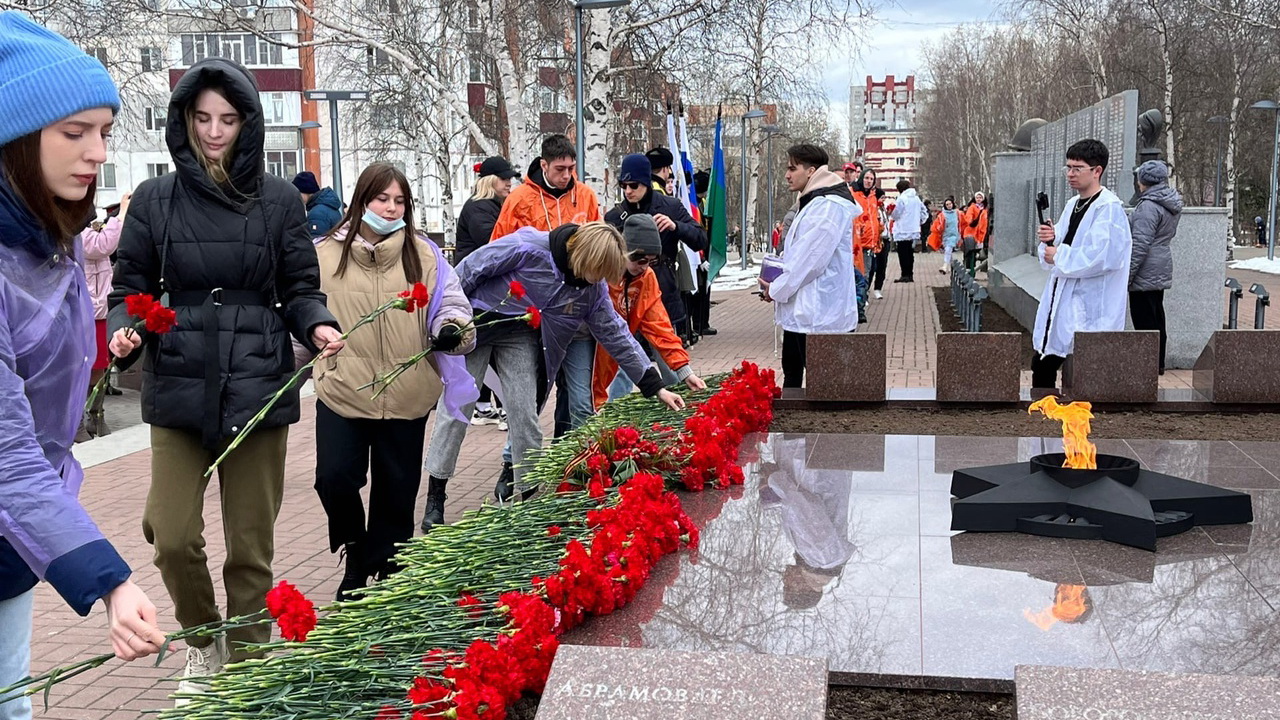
[1192,331,1280,404]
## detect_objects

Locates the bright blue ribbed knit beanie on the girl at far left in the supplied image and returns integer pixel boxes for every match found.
[0,10,120,145]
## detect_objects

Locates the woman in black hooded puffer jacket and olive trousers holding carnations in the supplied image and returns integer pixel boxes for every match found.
[108,59,342,676]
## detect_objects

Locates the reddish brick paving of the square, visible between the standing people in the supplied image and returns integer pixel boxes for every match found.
[22,245,1249,720]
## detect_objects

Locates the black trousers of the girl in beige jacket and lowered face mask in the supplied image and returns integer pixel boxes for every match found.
[316,401,426,569]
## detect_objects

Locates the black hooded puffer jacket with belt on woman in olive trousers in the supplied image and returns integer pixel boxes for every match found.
[108,58,338,447]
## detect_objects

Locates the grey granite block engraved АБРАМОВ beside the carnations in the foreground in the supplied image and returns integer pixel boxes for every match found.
[538,644,827,720]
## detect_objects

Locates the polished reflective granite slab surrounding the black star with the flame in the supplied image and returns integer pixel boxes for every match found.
[564,434,1280,689]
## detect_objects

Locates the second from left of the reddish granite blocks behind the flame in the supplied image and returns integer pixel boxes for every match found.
[934,333,1021,402]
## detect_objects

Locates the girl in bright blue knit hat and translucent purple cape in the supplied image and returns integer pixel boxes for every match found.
[0,12,164,720]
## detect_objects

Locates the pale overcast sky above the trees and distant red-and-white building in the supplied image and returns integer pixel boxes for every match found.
[823,0,998,146]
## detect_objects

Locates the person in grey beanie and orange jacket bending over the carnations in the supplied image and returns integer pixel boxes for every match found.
[591,214,707,410]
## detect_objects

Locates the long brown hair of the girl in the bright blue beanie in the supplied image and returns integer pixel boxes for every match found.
[0,131,97,255]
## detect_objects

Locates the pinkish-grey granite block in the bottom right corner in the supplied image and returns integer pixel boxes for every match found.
[1014,665,1280,720]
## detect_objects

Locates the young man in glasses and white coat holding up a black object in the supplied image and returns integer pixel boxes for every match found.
[1032,140,1133,389]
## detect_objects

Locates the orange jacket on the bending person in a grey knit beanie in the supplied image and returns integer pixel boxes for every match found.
[591,268,689,410]
